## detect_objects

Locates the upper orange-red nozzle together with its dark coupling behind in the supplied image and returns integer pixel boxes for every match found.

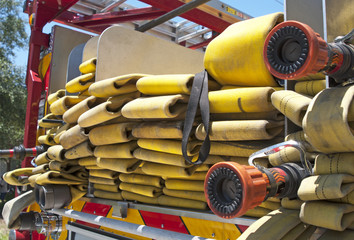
[263,21,354,83]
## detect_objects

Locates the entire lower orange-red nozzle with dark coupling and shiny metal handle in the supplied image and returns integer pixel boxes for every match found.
[204,141,312,218]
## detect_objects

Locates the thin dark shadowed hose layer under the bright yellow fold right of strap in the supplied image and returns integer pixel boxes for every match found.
[210,110,284,121]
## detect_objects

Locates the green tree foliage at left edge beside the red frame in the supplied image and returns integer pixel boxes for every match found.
[0,0,27,149]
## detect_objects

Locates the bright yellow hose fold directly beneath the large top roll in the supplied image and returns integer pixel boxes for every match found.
[209,87,275,113]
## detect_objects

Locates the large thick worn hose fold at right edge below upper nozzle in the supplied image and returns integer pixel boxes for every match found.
[303,86,354,153]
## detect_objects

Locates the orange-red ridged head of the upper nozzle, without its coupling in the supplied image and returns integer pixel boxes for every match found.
[263,21,329,80]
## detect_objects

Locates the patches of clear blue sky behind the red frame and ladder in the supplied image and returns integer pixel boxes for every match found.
[15,0,284,66]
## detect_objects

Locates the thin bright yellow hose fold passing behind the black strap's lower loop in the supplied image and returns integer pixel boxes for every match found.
[138,139,201,156]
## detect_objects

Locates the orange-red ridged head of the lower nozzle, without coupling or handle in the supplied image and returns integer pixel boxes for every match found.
[204,162,267,218]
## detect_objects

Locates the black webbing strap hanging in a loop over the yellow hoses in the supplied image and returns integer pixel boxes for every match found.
[182,70,210,164]
